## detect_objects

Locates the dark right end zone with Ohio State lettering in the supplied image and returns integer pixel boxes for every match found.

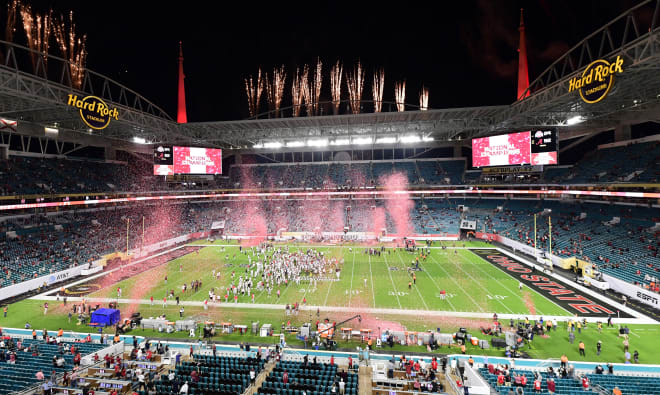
[470,249,632,318]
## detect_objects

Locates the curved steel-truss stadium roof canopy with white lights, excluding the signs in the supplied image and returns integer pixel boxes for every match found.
[0,0,660,152]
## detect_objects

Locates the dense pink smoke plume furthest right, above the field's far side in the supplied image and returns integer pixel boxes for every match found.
[380,173,415,237]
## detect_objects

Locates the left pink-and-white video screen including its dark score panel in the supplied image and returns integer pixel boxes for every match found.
[154,146,222,175]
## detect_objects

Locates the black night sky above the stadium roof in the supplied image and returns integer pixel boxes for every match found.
[25,0,638,122]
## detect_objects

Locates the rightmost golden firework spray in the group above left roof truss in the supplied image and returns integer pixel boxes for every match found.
[52,11,87,89]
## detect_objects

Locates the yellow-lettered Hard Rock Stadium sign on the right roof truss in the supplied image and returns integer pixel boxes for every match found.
[568,56,623,104]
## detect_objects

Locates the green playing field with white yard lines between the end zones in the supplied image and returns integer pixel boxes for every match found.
[84,240,569,315]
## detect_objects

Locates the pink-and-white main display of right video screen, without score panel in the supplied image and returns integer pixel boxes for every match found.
[472,132,531,167]
